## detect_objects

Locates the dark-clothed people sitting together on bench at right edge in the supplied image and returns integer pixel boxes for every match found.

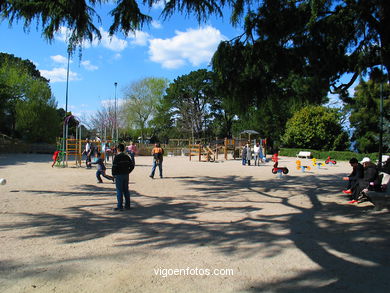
[343,157,390,204]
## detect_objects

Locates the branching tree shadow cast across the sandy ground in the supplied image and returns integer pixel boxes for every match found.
[0,174,390,292]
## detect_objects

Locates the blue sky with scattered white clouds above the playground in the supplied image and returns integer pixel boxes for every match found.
[0,3,242,121]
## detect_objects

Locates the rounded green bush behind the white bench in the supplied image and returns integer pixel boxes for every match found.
[282,106,348,150]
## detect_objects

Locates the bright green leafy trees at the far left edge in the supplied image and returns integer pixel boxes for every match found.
[0,53,61,142]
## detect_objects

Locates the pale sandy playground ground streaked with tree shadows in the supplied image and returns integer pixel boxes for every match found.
[0,155,390,293]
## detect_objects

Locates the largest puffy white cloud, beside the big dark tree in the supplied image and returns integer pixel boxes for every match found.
[149,26,226,69]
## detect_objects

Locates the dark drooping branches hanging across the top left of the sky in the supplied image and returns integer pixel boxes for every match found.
[0,0,230,51]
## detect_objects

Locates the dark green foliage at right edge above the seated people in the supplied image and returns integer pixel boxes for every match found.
[348,74,390,152]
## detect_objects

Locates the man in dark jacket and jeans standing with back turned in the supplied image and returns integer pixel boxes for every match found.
[112,144,134,211]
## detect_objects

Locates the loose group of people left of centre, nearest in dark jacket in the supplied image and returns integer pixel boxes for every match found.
[83,139,164,211]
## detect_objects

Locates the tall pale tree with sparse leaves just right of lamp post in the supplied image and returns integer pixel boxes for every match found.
[122,77,168,140]
